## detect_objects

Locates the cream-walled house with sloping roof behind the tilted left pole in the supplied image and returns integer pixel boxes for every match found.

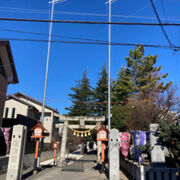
[4,92,60,143]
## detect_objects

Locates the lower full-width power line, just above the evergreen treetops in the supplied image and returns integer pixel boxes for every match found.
[0,38,180,51]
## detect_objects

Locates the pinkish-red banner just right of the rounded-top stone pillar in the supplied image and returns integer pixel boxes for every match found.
[120,132,130,157]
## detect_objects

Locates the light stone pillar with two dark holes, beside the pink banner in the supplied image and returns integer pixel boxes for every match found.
[109,129,119,180]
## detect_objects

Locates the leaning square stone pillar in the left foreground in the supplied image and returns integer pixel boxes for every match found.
[6,125,27,180]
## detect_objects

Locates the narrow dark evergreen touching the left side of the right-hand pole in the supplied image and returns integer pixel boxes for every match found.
[94,64,108,116]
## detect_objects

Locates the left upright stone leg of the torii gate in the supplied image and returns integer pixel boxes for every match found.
[60,120,68,163]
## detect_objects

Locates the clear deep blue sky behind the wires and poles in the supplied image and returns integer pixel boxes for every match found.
[0,0,180,113]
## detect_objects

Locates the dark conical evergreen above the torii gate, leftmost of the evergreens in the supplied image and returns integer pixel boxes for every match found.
[65,71,92,116]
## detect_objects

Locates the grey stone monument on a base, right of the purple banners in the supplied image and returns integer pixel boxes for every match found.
[150,124,165,167]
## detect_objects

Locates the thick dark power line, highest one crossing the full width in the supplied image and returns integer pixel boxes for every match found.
[0,16,180,27]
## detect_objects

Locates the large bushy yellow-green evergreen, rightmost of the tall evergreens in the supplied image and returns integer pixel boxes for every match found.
[113,46,172,100]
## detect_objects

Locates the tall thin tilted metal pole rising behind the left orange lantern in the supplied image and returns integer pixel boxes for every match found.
[37,0,66,169]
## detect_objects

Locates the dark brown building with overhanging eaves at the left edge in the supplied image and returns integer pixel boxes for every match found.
[0,40,18,127]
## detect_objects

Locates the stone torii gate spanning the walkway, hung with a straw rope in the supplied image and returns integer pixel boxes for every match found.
[60,115,105,162]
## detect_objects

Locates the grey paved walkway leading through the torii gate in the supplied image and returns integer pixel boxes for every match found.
[0,152,128,180]
